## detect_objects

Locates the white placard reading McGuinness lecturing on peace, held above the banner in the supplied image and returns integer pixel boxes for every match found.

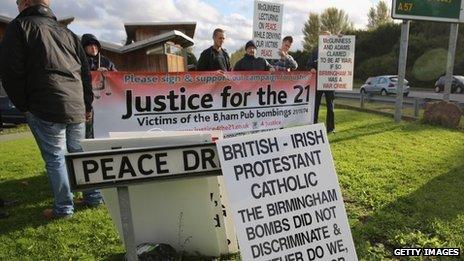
[253,1,284,59]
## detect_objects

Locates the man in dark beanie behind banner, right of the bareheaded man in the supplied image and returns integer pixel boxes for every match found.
[234,41,274,71]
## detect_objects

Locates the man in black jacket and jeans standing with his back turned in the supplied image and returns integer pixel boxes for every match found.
[0,0,97,219]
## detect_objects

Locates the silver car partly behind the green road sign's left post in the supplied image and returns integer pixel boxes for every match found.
[359,75,409,96]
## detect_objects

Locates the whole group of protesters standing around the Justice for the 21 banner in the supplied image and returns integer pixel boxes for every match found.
[0,0,333,219]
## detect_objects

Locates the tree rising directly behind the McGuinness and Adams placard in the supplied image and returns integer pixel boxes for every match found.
[303,7,353,51]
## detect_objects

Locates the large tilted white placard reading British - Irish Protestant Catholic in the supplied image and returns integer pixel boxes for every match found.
[217,124,357,261]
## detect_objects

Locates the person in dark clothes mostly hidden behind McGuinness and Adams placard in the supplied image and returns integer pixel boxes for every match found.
[307,31,335,133]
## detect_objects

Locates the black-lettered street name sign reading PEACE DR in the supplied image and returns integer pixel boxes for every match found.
[65,144,220,189]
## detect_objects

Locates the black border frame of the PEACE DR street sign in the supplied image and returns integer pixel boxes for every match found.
[65,143,222,191]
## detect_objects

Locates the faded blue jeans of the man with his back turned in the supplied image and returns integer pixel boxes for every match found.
[26,112,102,216]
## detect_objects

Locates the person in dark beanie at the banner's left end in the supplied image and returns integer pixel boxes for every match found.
[81,34,116,71]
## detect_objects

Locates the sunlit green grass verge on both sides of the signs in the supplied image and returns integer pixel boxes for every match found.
[0,110,464,260]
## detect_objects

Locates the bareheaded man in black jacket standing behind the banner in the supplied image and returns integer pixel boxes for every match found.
[197,28,231,71]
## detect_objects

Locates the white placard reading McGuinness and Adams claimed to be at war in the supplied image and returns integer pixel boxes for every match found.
[317,35,356,91]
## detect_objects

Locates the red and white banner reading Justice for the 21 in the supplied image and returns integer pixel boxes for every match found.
[92,72,316,138]
